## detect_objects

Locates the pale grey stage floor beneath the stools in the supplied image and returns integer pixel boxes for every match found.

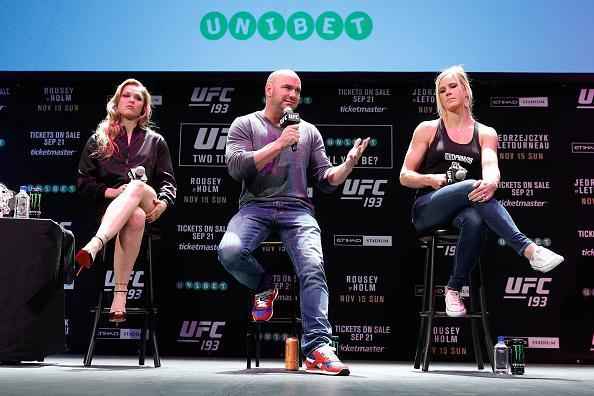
[0,356,594,396]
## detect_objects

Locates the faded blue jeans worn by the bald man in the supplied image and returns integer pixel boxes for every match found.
[218,201,332,355]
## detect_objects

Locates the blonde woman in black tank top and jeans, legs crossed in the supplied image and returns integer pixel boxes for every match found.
[400,66,563,316]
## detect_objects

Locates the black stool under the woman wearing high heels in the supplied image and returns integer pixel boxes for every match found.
[83,226,161,368]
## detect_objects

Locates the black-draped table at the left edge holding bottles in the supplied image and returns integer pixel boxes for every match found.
[0,218,71,362]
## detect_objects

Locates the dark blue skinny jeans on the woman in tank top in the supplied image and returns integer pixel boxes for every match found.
[412,180,531,290]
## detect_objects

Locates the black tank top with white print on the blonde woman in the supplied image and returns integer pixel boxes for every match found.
[417,120,482,195]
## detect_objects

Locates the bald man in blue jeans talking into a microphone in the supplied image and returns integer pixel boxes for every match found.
[218,70,369,375]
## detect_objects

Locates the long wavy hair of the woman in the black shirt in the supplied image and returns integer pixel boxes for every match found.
[93,78,153,158]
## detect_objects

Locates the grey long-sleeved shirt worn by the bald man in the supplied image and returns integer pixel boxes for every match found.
[225,111,336,208]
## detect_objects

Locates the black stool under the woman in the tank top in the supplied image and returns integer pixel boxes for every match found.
[414,228,494,371]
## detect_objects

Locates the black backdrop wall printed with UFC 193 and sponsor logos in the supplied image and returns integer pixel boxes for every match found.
[0,72,594,362]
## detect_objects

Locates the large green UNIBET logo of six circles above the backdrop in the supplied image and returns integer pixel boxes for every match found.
[200,11,373,41]
